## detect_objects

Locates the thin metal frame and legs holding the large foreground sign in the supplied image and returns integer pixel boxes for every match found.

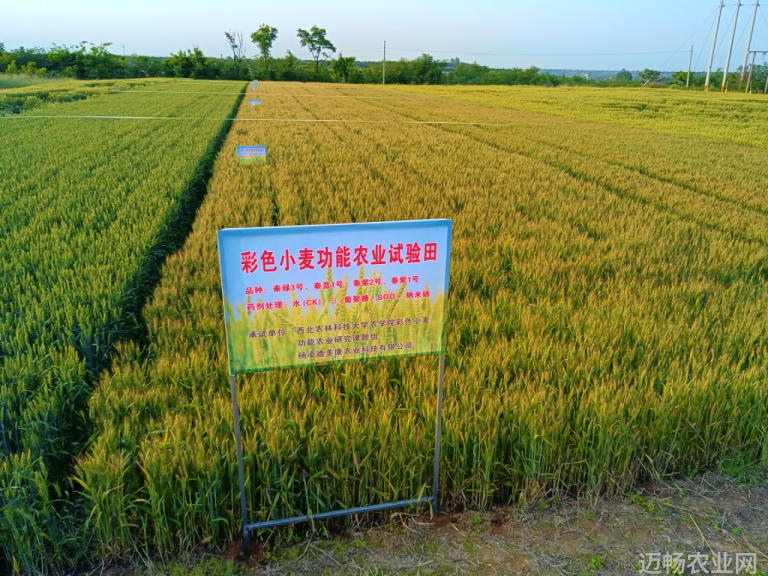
[218,219,453,552]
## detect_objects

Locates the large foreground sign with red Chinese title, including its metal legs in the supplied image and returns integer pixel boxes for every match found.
[218,220,452,551]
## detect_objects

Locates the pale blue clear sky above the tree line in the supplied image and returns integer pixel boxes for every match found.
[0,0,768,70]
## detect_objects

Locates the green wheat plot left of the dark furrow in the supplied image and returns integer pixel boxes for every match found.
[0,80,244,574]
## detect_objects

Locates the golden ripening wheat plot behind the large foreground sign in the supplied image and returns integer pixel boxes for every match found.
[69,82,768,558]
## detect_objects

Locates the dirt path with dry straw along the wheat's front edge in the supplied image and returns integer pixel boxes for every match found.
[114,472,768,576]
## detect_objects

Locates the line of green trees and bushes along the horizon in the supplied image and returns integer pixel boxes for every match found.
[0,34,768,92]
